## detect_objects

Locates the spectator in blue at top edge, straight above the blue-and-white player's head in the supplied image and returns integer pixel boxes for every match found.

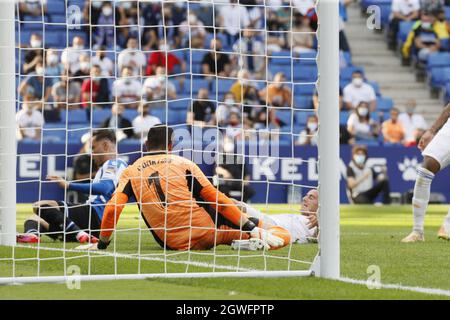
[92,1,114,48]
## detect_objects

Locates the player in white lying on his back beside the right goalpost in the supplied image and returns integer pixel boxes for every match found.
[236,189,319,244]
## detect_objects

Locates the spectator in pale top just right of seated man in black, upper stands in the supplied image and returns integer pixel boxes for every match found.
[233,29,267,80]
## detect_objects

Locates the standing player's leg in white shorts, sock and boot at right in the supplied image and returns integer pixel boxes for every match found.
[402,130,444,242]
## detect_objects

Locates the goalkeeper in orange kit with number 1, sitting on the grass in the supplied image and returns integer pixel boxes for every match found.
[79,125,290,250]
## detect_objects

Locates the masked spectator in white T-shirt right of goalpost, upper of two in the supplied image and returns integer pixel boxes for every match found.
[343,70,377,112]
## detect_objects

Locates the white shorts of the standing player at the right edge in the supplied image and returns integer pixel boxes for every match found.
[422,120,450,170]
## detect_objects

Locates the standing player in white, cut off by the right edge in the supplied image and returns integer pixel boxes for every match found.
[402,104,450,242]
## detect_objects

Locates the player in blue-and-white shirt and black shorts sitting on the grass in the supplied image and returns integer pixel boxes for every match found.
[17,130,127,243]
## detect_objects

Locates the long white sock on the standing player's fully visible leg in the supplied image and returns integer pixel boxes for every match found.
[412,167,434,234]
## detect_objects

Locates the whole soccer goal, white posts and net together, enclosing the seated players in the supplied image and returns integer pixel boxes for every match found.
[0,0,339,283]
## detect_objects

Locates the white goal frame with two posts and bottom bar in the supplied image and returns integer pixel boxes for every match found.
[0,0,340,284]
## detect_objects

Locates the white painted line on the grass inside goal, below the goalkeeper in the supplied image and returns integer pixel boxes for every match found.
[16,244,260,272]
